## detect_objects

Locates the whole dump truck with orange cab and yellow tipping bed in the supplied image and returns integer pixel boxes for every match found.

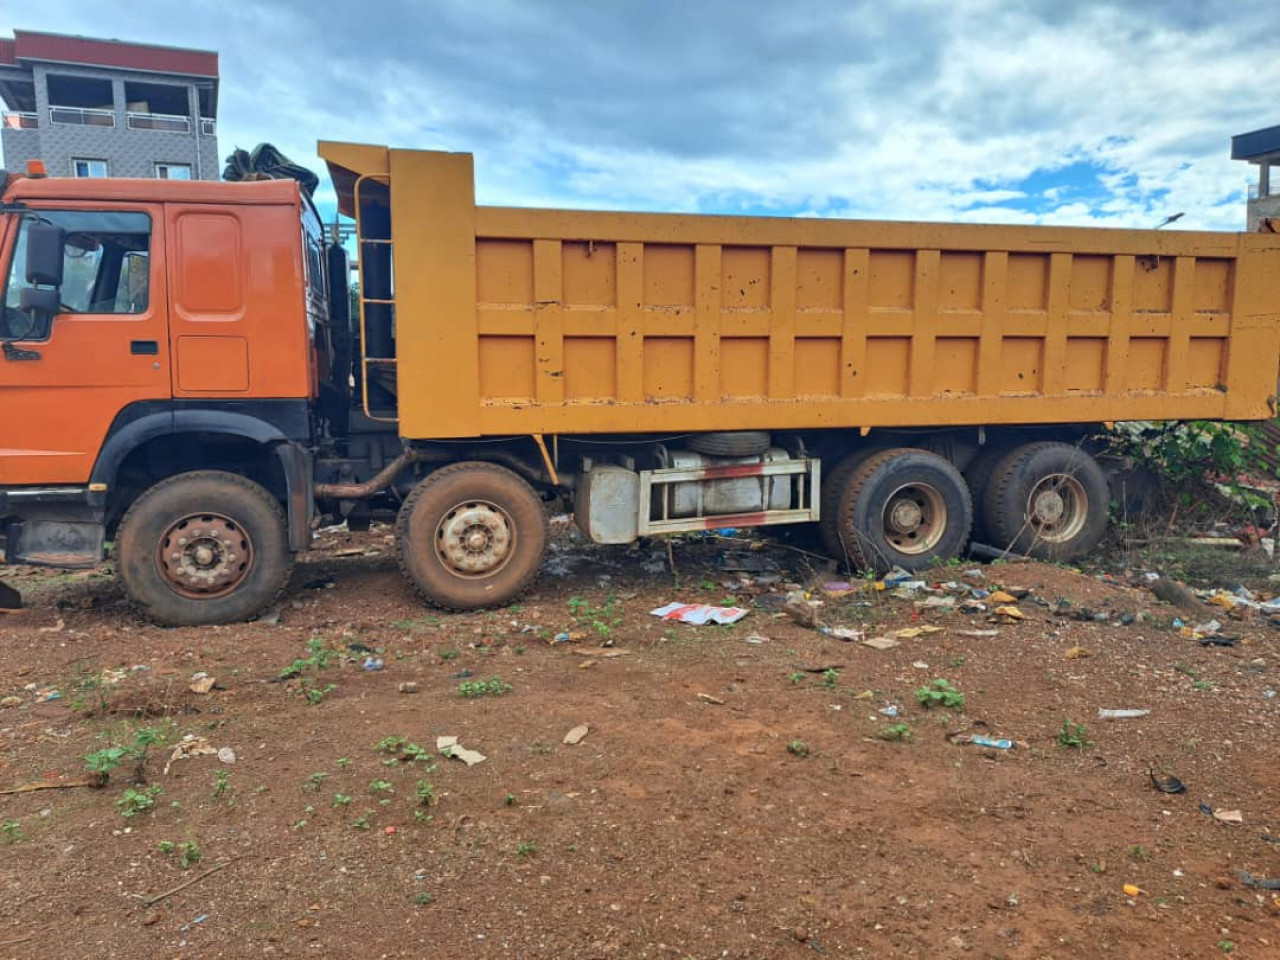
[0,142,1280,625]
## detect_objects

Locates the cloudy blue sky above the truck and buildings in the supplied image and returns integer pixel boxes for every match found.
[0,0,1280,229]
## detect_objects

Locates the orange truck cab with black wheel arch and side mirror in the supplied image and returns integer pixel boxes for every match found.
[0,177,330,624]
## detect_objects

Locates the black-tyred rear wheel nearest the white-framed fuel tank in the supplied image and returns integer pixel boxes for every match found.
[835,448,973,572]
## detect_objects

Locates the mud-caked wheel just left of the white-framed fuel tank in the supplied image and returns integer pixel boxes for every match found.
[396,462,547,611]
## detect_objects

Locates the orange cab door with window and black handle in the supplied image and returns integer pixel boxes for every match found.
[0,205,172,486]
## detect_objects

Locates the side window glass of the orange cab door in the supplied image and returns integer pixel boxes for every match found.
[0,210,151,337]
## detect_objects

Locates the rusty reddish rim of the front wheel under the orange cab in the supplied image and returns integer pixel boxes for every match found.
[156,513,253,600]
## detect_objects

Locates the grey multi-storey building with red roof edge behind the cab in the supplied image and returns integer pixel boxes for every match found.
[0,29,219,180]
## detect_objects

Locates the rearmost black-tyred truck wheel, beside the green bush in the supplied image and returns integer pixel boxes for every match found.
[983,443,1110,561]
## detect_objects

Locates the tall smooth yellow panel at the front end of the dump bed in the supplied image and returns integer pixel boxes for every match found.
[390,150,481,438]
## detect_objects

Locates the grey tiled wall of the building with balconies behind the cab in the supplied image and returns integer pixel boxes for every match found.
[0,64,221,180]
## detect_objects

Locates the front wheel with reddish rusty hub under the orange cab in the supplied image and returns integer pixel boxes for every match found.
[115,470,293,627]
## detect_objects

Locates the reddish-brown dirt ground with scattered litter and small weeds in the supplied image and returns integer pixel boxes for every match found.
[0,527,1280,959]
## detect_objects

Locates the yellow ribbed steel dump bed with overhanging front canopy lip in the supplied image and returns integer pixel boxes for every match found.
[320,143,1280,439]
